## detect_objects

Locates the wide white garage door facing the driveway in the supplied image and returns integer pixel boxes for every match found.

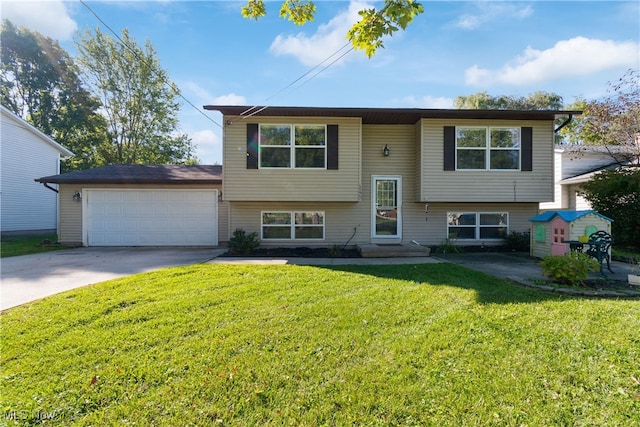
[83,189,218,246]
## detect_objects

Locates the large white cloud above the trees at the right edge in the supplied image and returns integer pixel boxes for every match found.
[465,37,640,86]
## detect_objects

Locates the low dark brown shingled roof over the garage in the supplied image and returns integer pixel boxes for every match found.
[35,165,222,184]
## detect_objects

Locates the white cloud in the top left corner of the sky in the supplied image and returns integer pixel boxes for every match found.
[1,0,78,41]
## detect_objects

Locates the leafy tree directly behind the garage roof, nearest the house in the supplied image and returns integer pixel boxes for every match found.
[76,28,194,164]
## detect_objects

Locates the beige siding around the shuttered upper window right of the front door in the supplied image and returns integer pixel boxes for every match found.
[420,119,554,203]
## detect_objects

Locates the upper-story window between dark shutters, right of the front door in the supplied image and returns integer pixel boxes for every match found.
[456,127,521,170]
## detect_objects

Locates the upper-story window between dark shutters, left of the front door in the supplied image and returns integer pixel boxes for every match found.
[258,125,327,169]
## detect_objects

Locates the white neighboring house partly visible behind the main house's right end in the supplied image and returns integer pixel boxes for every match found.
[540,146,619,210]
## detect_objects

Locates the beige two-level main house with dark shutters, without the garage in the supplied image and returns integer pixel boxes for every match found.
[205,105,580,251]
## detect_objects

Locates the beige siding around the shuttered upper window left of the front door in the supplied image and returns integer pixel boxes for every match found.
[223,116,362,202]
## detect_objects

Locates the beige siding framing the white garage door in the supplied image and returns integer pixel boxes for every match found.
[58,184,229,245]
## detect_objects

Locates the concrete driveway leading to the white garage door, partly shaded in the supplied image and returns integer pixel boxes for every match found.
[0,248,224,310]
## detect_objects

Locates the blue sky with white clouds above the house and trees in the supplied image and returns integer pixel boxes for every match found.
[0,0,640,164]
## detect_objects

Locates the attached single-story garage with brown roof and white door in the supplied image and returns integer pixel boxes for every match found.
[36,165,228,247]
